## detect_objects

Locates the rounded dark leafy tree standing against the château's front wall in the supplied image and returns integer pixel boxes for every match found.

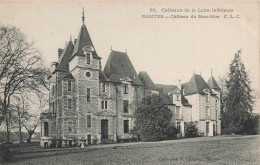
[133,95,173,141]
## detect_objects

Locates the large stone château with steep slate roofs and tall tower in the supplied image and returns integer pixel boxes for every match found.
[41,14,220,147]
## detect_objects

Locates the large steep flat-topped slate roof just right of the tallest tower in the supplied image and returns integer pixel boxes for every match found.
[104,50,143,85]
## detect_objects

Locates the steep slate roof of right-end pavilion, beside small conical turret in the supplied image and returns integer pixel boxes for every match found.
[182,74,209,96]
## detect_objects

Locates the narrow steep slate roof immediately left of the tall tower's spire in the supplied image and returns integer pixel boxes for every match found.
[56,41,74,71]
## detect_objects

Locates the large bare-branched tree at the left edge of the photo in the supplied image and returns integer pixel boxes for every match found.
[0,26,48,142]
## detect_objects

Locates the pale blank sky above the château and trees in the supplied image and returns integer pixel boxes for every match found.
[0,1,260,112]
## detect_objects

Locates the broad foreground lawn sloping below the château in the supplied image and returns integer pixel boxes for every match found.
[3,136,259,165]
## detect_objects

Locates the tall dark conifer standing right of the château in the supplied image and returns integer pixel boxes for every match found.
[222,50,253,134]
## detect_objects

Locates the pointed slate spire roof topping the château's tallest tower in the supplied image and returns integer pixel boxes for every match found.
[72,24,101,59]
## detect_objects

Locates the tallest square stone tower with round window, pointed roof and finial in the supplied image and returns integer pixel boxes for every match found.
[69,11,101,140]
